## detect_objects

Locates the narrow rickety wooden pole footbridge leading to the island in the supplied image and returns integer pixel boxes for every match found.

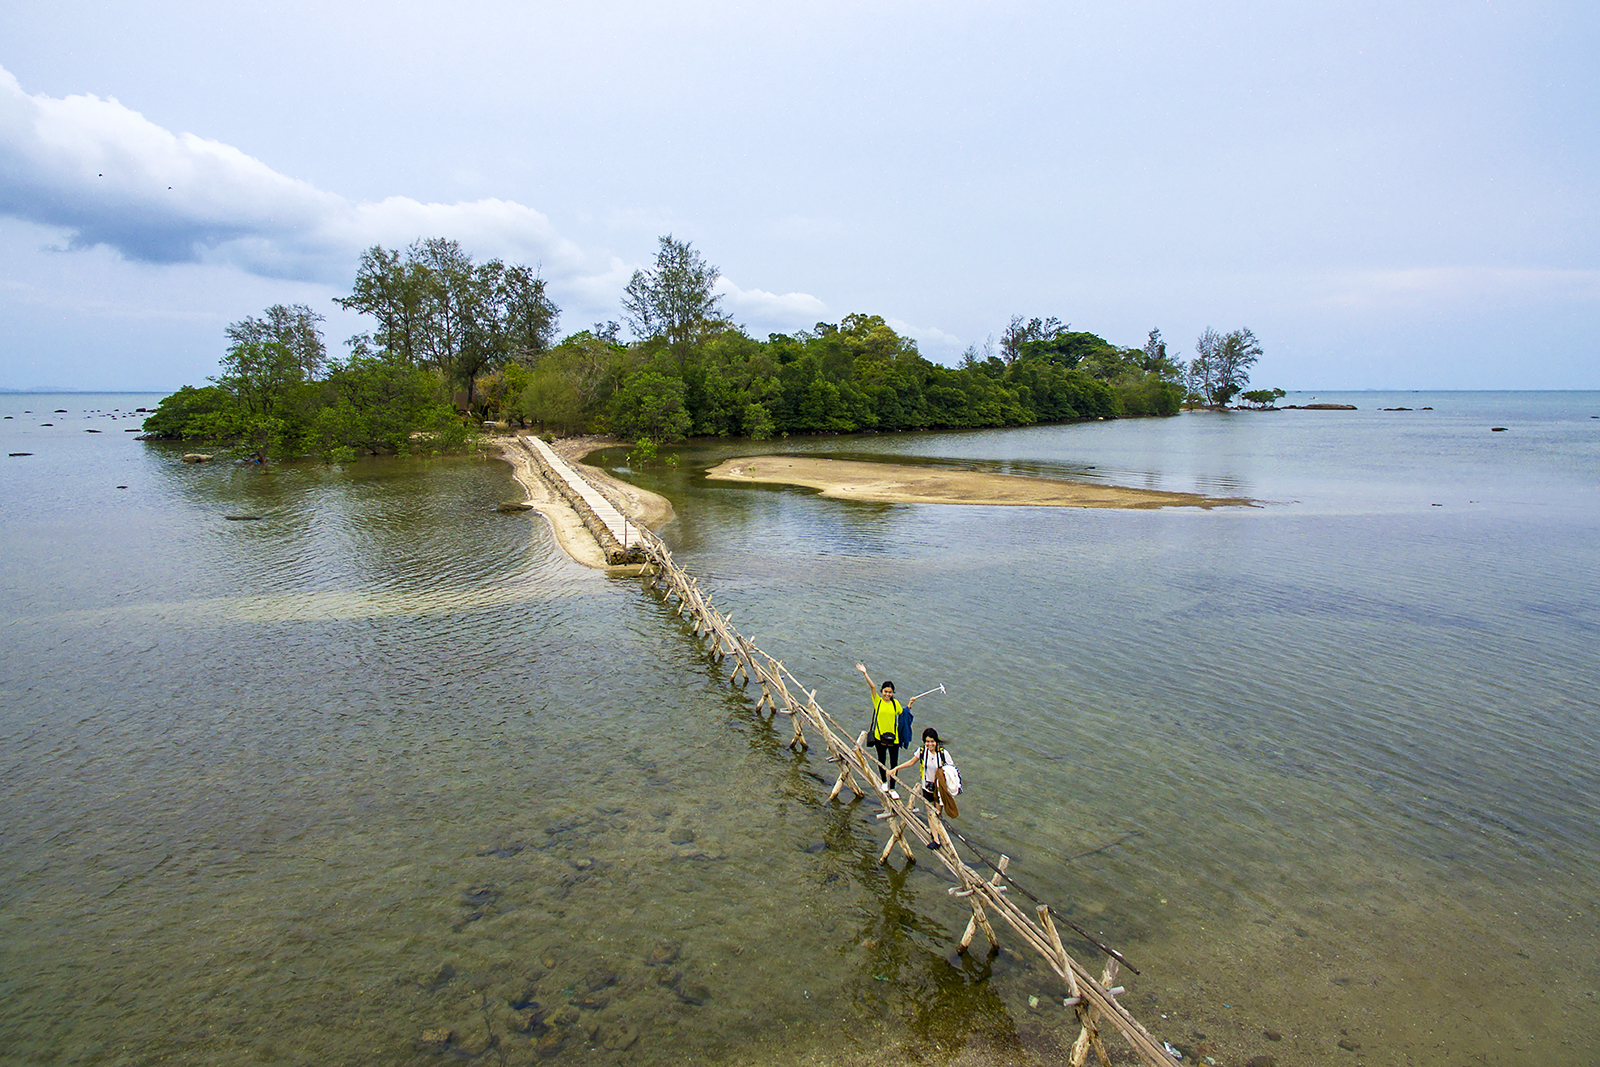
[522,437,1178,1067]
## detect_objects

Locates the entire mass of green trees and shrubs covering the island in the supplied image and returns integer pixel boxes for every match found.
[146,235,1209,461]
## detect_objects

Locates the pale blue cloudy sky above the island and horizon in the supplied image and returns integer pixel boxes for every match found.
[0,0,1600,390]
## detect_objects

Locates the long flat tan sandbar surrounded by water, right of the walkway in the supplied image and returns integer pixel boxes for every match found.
[706,456,1253,509]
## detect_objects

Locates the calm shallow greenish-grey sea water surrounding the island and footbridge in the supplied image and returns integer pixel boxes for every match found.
[0,392,1600,1067]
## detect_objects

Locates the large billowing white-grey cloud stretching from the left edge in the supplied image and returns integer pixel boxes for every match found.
[0,69,595,286]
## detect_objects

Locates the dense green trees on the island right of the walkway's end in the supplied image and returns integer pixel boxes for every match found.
[492,235,1184,442]
